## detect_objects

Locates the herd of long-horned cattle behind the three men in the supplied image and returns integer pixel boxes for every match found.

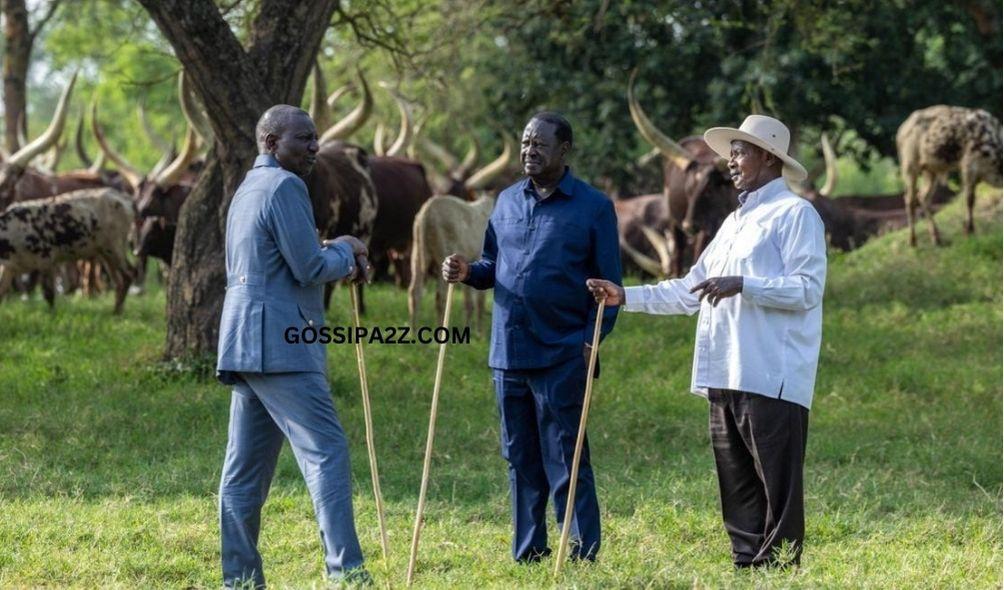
[0,68,1001,317]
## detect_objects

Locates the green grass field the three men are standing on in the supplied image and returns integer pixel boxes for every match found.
[0,193,1002,589]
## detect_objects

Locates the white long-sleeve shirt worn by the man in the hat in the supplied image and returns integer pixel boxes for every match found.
[624,179,826,407]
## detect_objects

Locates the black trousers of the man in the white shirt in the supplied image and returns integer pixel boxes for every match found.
[708,389,809,567]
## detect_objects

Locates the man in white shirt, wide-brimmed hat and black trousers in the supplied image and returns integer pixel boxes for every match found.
[586,115,826,567]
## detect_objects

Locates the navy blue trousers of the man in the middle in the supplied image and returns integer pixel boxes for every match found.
[494,355,599,561]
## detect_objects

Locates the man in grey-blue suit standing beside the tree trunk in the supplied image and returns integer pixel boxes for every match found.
[217,104,369,587]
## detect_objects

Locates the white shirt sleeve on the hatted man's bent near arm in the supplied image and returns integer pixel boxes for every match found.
[742,205,826,311]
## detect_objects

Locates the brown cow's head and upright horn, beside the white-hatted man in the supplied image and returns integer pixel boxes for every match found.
[628,70,739,277]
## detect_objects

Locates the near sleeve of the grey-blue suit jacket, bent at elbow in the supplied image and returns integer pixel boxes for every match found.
[264,177,355,287]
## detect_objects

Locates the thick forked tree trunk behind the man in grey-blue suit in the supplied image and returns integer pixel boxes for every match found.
[140,0,337,358]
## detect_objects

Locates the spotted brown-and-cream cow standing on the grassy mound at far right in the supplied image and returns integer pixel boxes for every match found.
[896,104,1001,246]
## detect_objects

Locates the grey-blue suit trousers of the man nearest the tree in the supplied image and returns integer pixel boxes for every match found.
[220,372,362,587]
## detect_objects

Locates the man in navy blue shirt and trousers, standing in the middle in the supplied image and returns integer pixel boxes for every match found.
[443,112,620,562]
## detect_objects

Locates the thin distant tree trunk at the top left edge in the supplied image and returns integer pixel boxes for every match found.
[2,0,33,154]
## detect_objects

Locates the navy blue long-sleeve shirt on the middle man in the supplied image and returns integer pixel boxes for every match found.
[465,169,620,369]
